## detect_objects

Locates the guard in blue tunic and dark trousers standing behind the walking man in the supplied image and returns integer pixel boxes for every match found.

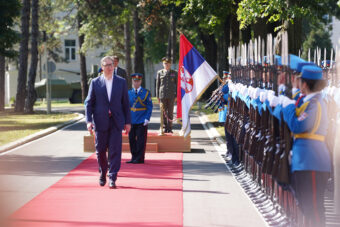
[127,73,153,164]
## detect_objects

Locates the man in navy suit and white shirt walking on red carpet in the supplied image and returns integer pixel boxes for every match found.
[85,56,131,188]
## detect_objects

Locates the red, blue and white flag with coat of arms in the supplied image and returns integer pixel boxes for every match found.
[177,34,217,137]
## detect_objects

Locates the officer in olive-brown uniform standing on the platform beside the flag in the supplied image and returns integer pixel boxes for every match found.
[156,58,177,133]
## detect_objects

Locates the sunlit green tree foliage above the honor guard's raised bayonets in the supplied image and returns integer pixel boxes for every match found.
[237,0,340,54]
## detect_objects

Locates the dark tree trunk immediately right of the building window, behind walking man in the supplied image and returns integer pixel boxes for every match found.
[78,18,89,102]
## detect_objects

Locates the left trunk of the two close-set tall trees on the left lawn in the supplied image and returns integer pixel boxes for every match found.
[14,0,31,112]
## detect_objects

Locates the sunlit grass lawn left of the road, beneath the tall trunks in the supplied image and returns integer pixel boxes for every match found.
[0,109,77,146]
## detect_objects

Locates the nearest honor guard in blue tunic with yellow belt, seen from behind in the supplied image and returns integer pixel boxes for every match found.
[282,65,331,226]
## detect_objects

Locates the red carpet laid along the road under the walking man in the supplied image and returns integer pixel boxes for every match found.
[7,153,183,227]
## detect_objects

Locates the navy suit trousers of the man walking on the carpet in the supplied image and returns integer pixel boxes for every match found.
[95,119,122,181]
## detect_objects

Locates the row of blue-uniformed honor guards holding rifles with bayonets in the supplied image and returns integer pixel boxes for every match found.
[208,50,340,226]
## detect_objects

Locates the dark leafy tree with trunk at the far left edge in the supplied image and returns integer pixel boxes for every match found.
[0,0,20,111]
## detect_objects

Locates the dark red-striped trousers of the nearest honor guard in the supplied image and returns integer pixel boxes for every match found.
[292,171,329,227]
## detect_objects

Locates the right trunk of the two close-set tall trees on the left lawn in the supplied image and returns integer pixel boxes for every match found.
[25,0,39,113]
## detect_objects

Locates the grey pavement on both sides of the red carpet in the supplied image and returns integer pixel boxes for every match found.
[0,105,266,227]
